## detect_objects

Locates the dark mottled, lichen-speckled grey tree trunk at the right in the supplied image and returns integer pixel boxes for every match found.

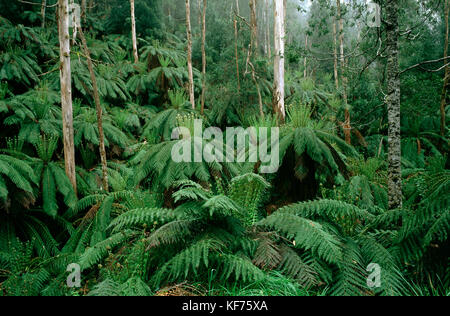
[386,0,402,209]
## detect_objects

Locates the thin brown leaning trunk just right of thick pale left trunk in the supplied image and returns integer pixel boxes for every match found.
[78,27,109,192]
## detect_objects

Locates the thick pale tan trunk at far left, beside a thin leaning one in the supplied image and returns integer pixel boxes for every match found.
[58,0,77,192]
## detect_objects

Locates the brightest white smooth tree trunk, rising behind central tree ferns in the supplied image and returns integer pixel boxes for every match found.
[273,0,286,122]
